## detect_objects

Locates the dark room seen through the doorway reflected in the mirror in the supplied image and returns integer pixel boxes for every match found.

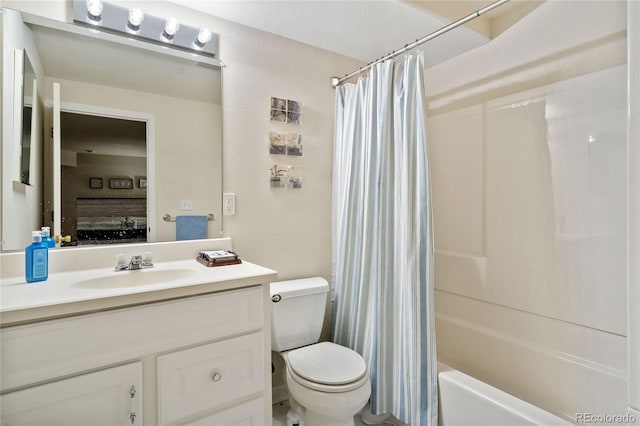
[61,112,147,245]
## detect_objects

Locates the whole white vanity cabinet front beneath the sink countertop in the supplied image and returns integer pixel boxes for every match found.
[0,284,271,426]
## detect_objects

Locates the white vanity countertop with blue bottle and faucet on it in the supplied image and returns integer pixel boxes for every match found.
[0,259,277,327]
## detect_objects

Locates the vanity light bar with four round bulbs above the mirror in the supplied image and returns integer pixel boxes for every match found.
[73,0,218,58]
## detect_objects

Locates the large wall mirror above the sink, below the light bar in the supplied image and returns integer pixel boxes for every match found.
[2,9,222,251]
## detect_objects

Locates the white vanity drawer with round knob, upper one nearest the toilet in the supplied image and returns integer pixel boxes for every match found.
[158,333,265,424]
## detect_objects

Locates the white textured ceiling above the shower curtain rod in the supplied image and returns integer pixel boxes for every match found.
[171,0,500,67]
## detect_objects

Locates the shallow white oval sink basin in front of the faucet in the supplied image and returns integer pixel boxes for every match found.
[73,269,194,289]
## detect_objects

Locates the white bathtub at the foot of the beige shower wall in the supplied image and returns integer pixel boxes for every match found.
[438,363,573,426]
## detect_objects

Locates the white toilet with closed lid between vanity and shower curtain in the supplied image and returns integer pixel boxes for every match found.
[270,277,371,426]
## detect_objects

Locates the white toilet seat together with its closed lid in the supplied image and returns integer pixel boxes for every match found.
[285,342,368,393]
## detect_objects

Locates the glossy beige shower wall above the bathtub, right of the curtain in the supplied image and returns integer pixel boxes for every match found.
[426,2,627,421]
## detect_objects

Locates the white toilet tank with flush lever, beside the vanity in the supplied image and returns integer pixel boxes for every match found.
[270,277,329,352]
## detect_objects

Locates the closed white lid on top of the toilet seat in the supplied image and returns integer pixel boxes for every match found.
[287,342,367,386]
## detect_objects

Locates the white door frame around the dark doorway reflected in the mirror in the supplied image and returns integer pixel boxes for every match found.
[43,97,157,242]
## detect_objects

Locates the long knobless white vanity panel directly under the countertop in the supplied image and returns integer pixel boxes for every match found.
[0,286,264,391]
